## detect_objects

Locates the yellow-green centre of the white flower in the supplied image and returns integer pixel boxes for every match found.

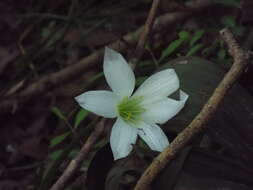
[118,96,145,124]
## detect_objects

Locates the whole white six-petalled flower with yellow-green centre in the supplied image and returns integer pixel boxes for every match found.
[75,48,188,160]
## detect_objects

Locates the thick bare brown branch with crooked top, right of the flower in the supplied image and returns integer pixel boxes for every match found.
[134,29,250,190]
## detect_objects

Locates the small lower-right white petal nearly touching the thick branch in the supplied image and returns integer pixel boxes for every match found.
[138,122,169,152]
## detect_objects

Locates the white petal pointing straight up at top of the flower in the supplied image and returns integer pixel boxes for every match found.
[104,47,135,97]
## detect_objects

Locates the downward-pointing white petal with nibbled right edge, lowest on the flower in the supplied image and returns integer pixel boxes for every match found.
[110,118,137,160]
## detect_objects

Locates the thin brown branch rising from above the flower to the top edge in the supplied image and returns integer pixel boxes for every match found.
[135,0,160,60]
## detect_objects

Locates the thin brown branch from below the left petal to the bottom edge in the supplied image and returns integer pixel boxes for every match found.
[50,119,104,190]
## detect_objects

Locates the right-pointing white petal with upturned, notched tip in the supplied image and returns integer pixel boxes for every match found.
[141,91,189,124]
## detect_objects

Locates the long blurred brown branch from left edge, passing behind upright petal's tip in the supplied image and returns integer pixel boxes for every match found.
[0,0,212,112]
